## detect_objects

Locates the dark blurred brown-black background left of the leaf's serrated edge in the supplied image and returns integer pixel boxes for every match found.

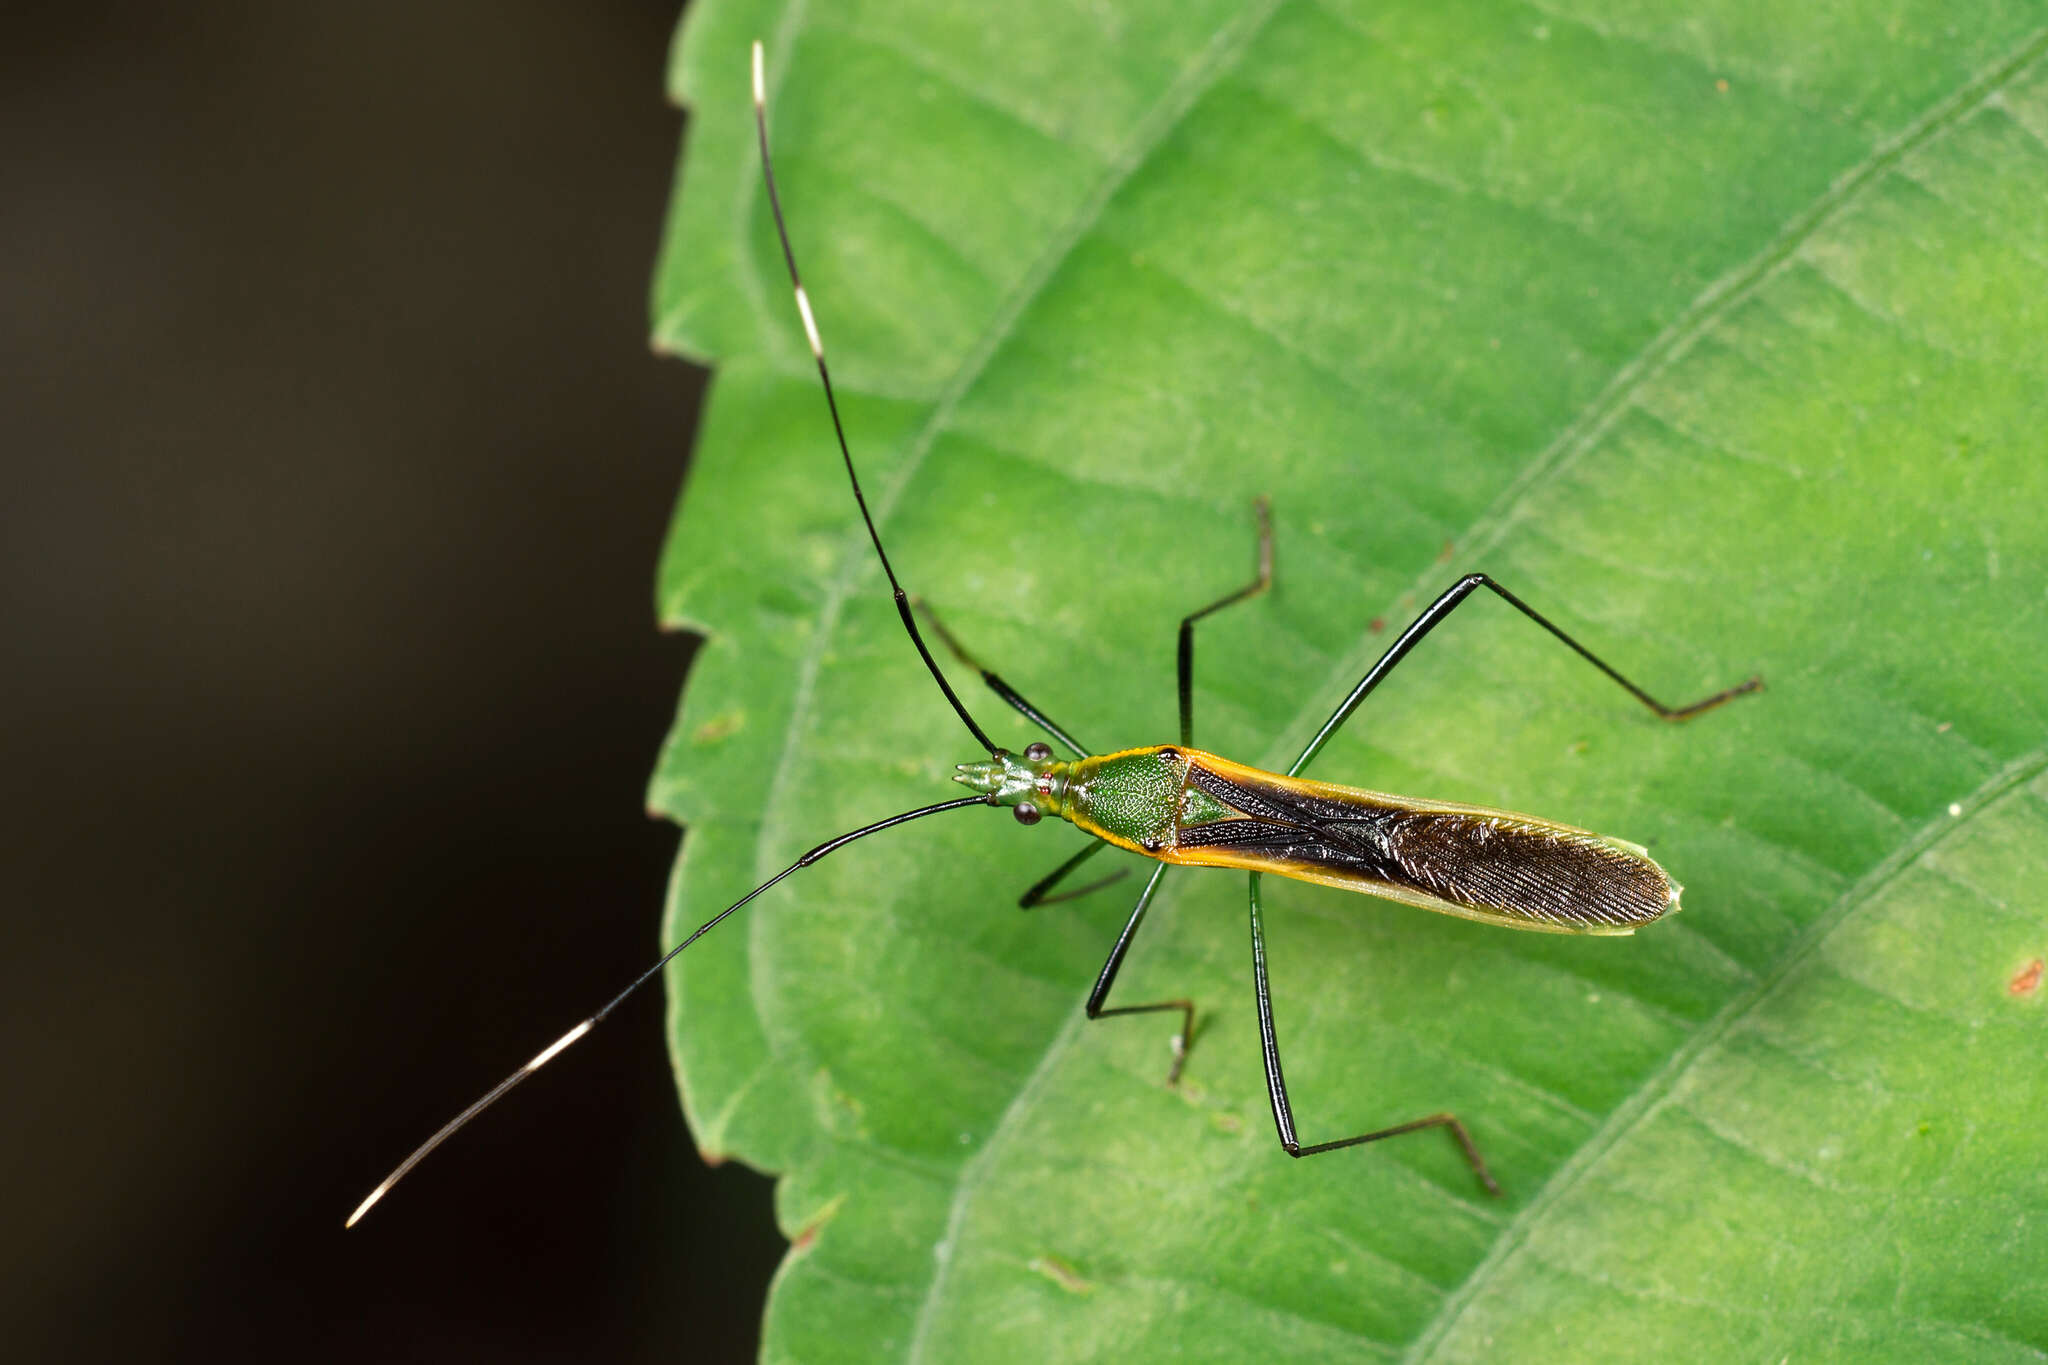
[0,0,780,1361]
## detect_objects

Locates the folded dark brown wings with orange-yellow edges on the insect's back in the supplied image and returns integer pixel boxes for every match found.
[1167,753,1679,933]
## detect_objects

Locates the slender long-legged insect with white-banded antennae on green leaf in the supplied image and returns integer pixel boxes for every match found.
[348,43,1763,1226]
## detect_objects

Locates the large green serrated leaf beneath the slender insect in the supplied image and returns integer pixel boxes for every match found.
[651,0,2048,1361]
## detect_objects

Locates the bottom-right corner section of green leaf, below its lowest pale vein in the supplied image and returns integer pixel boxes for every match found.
[1425,765,2048,1361]
